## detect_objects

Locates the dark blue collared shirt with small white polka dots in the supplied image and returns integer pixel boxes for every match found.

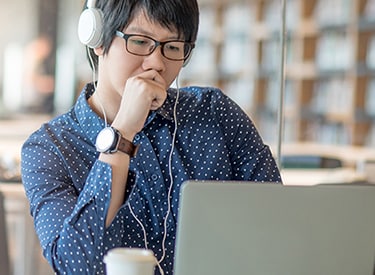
[22,84,281,274]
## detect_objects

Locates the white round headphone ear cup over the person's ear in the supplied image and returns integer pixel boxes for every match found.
[78,0,103,48]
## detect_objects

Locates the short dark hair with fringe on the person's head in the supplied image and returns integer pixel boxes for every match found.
[85,0,199,68]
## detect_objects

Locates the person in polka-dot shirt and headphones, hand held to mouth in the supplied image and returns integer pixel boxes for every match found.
[22,0,281,274]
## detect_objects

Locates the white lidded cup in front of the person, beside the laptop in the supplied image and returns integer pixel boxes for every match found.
[103,247,156,275]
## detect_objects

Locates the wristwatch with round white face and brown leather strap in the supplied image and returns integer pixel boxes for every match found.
[95,126,139,157]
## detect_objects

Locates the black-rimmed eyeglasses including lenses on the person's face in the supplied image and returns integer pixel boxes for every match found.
[116,31,195,61]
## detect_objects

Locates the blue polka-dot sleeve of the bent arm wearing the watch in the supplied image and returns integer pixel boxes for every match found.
[22,137,112,274]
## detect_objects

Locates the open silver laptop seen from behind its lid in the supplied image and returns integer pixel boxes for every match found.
[174,181,375,275]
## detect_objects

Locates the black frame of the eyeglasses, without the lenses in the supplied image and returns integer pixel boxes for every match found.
[116,31,195,61]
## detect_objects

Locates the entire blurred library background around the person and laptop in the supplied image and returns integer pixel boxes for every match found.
[0,0,375,275]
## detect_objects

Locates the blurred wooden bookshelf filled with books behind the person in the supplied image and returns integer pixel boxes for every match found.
[180,0,375,146]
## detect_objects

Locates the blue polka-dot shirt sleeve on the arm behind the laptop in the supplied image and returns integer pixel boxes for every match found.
[213,91,281,182]
